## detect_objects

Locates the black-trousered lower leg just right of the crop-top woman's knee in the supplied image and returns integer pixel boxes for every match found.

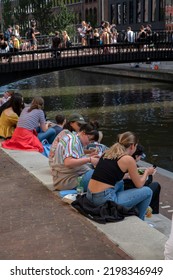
[148,182,161,214]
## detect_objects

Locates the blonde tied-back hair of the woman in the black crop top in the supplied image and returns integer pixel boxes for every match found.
[103,131,138,159]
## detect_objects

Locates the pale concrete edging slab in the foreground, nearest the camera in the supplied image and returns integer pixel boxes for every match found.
[93,216,167,260]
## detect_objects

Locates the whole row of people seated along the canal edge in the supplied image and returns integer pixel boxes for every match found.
[0,93,160,220]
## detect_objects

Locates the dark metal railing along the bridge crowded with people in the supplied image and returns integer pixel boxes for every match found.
[0,32,173,74]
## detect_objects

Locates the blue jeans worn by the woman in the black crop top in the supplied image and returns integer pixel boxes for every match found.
[86,181,153,220]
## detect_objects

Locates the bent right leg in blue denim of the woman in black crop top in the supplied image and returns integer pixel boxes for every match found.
[115,186,152,220]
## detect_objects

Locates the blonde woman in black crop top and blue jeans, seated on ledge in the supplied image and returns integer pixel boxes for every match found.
[87,131,155,220]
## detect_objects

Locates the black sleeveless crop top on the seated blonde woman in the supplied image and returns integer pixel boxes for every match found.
[91,158,125,186]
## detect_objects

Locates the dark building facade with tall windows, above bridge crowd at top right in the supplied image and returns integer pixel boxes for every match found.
[108,0,173,30]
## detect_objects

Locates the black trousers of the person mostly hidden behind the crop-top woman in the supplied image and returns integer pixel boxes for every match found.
[124,179,161,214]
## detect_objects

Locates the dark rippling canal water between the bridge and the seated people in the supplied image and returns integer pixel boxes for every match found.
[0,69,173,171]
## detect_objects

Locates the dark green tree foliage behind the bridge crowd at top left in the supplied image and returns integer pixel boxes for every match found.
[1,0,75,35]
